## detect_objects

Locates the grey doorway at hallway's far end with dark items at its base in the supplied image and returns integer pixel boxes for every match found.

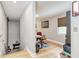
[6,20,20,53]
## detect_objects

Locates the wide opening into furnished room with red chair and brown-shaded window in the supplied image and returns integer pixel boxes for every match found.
[36,1,71,58]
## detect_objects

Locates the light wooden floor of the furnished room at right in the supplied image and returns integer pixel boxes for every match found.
[37,41,63,58]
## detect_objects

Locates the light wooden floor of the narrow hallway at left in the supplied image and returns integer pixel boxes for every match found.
[2,50,31,58]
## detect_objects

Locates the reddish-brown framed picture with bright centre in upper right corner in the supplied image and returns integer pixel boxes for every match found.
[72,1,79,16]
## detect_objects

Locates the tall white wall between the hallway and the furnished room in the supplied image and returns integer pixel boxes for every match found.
[20,2,36,53]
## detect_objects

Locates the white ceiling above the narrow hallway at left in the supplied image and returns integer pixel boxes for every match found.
[2,1,28,20]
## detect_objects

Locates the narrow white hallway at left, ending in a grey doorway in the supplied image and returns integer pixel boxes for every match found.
[0,1,36,57]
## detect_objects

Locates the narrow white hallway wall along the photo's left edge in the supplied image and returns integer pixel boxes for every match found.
[0,4,7,55]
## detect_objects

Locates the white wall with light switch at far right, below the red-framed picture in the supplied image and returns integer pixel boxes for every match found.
[71,16,79,58]
